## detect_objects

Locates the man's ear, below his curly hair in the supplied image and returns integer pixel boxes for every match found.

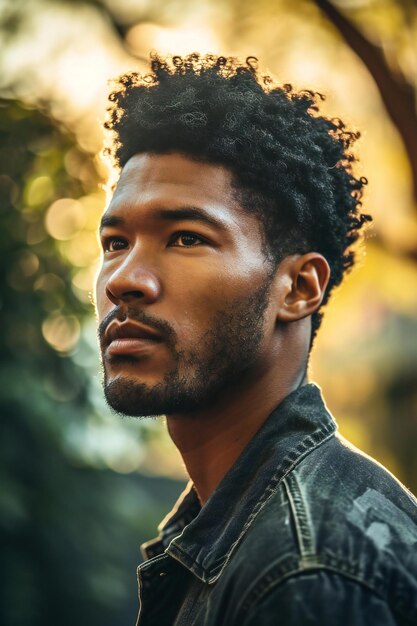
[276,252,330,322]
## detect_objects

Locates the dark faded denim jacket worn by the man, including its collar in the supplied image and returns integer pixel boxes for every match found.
[138,383,417,626]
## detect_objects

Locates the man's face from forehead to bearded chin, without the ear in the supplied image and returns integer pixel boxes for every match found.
[96,154,275,415]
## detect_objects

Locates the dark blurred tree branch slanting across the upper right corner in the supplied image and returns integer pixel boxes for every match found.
[314,0,417,205]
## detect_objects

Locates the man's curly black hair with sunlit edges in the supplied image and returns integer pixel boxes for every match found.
[105,53,372,347]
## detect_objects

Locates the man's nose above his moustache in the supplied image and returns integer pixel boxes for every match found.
[106,246,161,304]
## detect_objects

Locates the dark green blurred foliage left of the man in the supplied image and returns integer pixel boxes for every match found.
[0,101,181,626]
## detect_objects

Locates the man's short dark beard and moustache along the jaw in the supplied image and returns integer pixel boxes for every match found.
[99,277,272,417]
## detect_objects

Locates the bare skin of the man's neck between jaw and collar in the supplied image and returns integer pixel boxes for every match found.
[167,324,308,505]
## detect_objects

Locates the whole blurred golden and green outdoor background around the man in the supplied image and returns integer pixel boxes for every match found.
[0,0,417,626]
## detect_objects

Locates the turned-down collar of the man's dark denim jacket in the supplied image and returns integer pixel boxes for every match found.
[142,383,337,583]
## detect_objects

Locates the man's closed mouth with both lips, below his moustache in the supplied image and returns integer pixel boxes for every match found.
[105,321,162,357]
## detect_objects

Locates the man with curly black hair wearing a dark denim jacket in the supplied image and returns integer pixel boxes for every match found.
[96,55,417,626]
